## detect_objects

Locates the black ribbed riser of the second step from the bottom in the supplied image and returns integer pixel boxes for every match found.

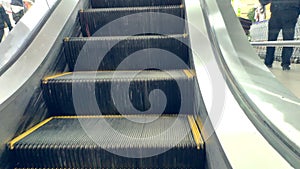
[42,75,196,115]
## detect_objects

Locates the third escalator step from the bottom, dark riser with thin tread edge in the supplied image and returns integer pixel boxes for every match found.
[64,34,191,71]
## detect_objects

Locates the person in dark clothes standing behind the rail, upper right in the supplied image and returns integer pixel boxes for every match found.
[259,0,300,70]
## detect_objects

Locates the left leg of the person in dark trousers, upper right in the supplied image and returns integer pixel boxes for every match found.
[265,13,281,67]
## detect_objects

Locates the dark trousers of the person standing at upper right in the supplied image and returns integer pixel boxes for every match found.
[265,9,299,66]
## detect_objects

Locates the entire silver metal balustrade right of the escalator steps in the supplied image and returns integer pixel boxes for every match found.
[186,0,300,168]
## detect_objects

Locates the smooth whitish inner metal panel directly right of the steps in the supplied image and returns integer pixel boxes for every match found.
[185,0,292,168]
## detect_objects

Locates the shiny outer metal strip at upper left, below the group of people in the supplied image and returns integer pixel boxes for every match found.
[0,0,60,76]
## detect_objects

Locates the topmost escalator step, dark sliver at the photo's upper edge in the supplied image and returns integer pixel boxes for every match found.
[91,0,182,8]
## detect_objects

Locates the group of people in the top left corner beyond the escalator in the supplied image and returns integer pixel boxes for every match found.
[0,0,33,42]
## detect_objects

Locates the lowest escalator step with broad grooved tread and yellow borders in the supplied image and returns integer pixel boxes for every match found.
[9,116,204,169]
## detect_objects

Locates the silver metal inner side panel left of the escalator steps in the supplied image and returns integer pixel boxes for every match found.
[0,0,87,168]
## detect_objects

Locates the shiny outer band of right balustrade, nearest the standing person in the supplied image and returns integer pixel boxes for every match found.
[202,0,300,168]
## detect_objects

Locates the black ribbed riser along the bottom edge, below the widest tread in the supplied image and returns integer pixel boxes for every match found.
[15,146,204,169]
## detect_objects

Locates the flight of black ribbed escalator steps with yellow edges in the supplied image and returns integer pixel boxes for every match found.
[8,0,205,169]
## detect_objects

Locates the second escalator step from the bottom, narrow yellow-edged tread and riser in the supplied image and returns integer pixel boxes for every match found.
[42,70,196,115]
